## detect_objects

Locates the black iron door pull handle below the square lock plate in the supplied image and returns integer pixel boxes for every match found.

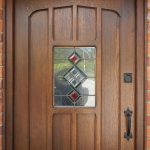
[124,108,132,141]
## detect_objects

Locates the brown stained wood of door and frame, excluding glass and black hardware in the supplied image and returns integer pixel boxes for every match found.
[5,0,144,150]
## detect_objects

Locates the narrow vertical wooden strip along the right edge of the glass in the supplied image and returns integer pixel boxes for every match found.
[95,7,102,150]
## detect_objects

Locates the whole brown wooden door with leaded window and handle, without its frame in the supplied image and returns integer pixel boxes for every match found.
[6,0,143,150]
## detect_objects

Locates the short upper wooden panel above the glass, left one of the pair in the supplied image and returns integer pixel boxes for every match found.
[53,7,73,41]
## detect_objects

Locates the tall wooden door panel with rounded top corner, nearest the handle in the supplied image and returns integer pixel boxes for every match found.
[101,10,120,150]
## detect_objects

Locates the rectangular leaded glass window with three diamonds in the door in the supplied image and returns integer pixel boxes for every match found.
[53,47,96,107]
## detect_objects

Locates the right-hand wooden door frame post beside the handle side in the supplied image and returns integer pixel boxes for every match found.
[135,0,145,150]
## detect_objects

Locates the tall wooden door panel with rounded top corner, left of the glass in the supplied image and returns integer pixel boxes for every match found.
[29,11,48,150]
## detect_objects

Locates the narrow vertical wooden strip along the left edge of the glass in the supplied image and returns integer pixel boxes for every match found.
[47,7,54,150]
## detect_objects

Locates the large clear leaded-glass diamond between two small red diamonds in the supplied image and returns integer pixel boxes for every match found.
[64,67,86,88]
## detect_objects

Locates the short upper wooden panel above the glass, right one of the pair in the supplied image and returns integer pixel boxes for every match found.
[77,6,97,41]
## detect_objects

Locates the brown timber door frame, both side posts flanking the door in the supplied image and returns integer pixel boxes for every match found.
[3,0,147,150]
